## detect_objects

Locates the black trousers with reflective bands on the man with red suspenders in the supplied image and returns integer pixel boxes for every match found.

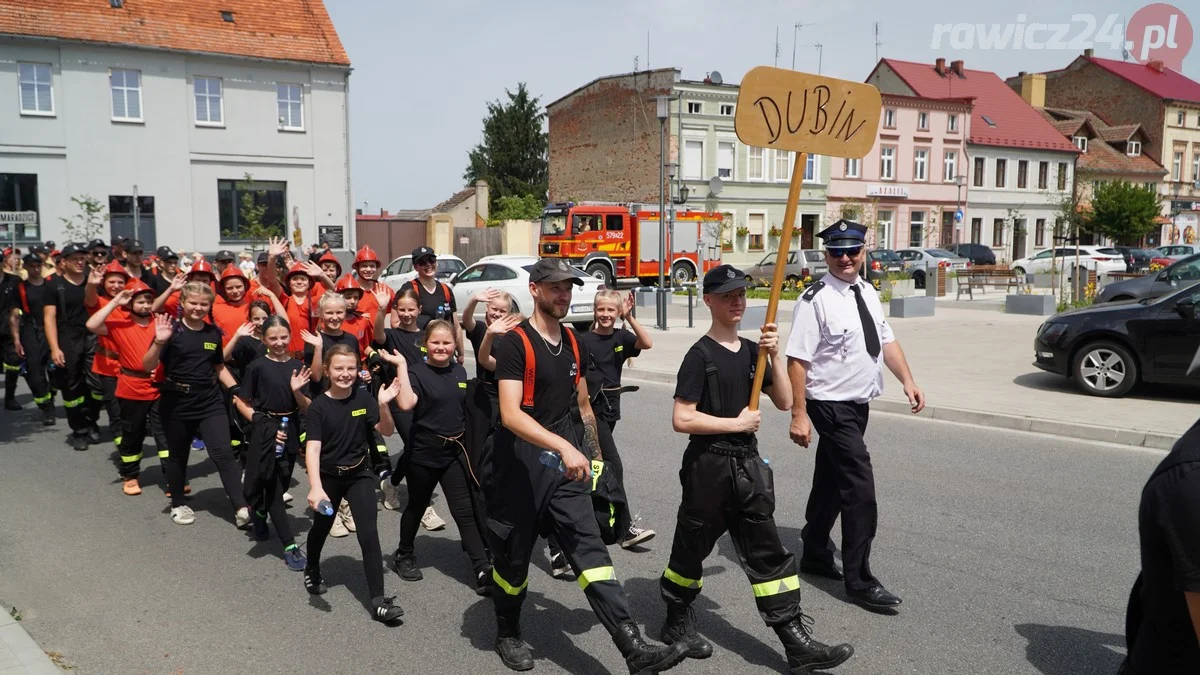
[480,416,630,635]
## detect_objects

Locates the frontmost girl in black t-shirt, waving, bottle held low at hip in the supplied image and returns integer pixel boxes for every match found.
[304,345,404,621]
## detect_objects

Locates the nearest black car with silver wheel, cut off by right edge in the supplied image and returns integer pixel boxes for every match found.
[1033,286,1200,396]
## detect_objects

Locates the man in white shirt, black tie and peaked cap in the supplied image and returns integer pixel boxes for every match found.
[787,220,925,613]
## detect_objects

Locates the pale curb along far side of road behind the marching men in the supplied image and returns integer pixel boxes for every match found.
[625,366,1178,450]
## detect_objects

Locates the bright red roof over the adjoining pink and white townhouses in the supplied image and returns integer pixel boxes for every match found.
[868,59,1079,153]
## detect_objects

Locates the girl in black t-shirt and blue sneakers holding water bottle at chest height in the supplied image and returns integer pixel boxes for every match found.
[234,316,310,572]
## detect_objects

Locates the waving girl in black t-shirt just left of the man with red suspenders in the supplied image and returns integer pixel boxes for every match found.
[384,319,491,595]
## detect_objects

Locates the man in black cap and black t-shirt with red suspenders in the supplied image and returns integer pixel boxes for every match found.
[477,255,684,673]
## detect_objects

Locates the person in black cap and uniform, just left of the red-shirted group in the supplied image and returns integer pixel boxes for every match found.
[43,244,101,450]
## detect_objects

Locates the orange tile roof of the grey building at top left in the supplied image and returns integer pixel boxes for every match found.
[0,0,350,66]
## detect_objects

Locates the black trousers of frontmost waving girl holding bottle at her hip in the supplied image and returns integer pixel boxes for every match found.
[308,466,383,598]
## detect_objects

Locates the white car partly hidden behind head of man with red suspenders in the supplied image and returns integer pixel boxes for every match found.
[449,255,605,330]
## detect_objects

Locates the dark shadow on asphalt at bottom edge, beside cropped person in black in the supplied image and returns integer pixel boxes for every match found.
[1013,623,1126,675]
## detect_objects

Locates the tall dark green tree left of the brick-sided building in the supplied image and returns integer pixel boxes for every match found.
[463,82,550,213]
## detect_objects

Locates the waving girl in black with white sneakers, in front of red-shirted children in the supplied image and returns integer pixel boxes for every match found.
[142,282,250,527]
